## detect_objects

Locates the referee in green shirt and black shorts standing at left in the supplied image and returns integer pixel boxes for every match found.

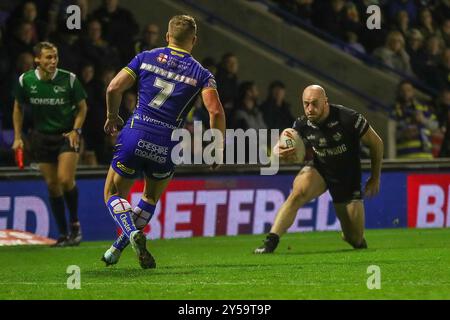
[12,42,87,247]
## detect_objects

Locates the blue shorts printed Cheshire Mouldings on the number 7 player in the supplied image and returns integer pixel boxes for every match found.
[111,125,177,180]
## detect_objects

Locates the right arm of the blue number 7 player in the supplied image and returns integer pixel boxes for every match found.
[202,89,226,169]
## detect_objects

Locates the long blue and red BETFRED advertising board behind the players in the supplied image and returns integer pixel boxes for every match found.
[0,172,444,240]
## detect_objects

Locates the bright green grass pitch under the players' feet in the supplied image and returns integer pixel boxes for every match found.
[0,229,450,299]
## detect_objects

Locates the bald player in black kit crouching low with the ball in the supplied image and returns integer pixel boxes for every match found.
[254,85,383,253]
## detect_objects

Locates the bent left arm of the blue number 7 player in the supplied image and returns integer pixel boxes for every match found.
[104,69,135,135]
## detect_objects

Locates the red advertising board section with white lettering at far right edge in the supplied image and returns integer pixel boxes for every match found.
[407,174,450,228]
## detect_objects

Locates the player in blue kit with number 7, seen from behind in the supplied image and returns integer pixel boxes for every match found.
[102,15,225,269]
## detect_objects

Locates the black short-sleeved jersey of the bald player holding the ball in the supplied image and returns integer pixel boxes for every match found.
[293,104,369,181]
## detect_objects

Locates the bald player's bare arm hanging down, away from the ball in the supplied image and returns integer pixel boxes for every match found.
[361,127,384,197]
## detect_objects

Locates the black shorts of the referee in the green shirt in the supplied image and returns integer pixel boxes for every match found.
[31,131,78,163]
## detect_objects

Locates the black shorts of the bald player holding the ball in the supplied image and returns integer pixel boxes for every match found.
[308,164,363,203]
